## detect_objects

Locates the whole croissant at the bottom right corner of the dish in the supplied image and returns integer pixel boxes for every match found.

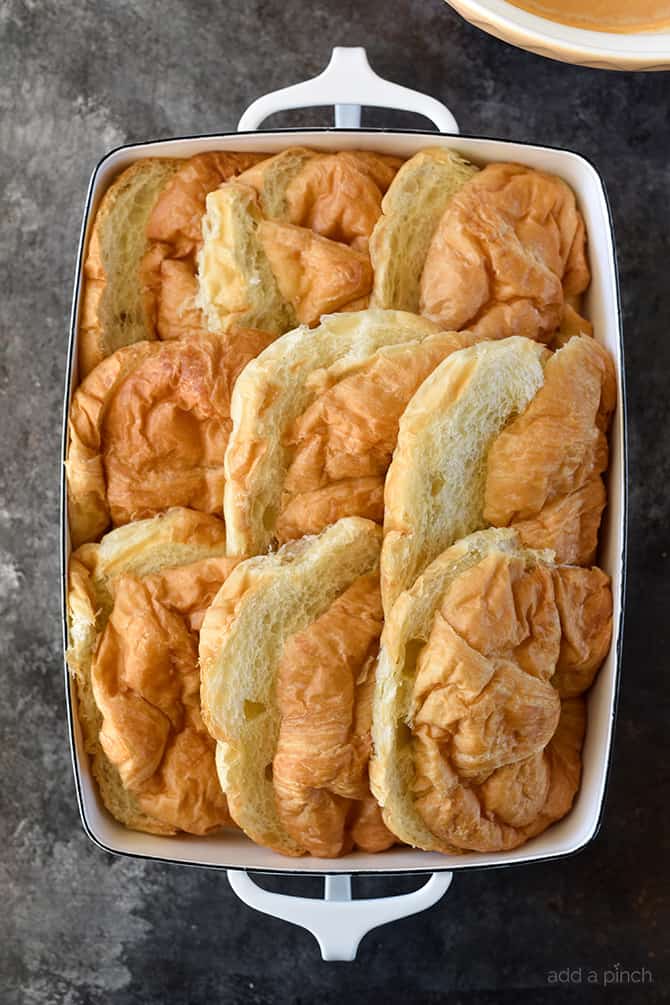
[371,531,612,851]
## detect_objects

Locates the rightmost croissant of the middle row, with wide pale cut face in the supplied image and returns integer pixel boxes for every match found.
[382,336,616,610]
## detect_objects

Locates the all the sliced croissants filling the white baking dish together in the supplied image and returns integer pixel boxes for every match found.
[66,148,616,858]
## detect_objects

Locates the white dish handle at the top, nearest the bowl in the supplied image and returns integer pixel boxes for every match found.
[237,45,458,133]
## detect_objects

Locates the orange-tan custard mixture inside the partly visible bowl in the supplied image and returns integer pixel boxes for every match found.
[510,0,670,32]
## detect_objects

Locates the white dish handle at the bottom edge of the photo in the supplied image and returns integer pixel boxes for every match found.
[228,869,453,961]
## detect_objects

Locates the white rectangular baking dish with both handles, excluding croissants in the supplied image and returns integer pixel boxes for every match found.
[62,49,626,959]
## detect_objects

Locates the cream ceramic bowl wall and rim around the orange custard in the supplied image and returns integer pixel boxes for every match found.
[446,0,670,70]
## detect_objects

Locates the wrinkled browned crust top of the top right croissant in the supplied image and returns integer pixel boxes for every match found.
[420,164,590,342]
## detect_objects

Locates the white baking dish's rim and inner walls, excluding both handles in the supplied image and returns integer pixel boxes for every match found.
[61,130,626,874]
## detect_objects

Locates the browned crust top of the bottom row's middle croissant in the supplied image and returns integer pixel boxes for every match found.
[272,573,394,858]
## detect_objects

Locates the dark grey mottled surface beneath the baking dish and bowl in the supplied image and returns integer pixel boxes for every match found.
[0,0,670,1005]
